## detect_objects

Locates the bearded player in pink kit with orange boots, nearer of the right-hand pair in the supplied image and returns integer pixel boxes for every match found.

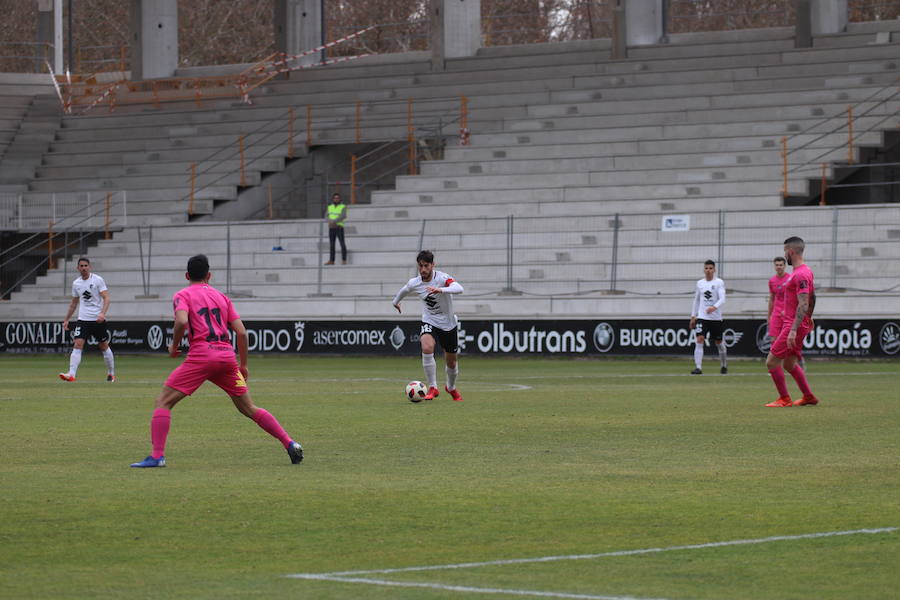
[766,237,819,408]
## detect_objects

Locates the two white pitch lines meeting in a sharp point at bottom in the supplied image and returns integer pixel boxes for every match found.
[285,527,900,600]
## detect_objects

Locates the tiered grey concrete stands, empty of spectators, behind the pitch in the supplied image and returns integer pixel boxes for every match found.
[0,23,900,319]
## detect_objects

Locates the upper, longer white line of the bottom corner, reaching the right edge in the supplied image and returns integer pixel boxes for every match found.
[298,527,900,577]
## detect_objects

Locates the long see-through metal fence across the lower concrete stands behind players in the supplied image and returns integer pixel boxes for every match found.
[21,206,900,298]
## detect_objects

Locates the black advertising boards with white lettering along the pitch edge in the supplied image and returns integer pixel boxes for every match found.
[0,319,900,357]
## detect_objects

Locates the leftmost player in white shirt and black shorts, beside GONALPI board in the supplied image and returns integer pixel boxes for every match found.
[59,257,116,383]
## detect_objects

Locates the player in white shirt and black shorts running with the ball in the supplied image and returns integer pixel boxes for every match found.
[392,250,463,402]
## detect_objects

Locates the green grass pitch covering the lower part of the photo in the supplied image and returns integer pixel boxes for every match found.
[0,350,900,600]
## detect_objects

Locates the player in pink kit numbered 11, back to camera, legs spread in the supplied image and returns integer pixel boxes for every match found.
[131,254,303,468]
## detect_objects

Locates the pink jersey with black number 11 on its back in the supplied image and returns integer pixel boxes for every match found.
[172,283,240,361]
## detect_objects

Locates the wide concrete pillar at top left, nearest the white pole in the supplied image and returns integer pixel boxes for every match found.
[131,0,178,81]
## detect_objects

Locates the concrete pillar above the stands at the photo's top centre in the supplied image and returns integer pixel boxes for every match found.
[429,0,481,71]
